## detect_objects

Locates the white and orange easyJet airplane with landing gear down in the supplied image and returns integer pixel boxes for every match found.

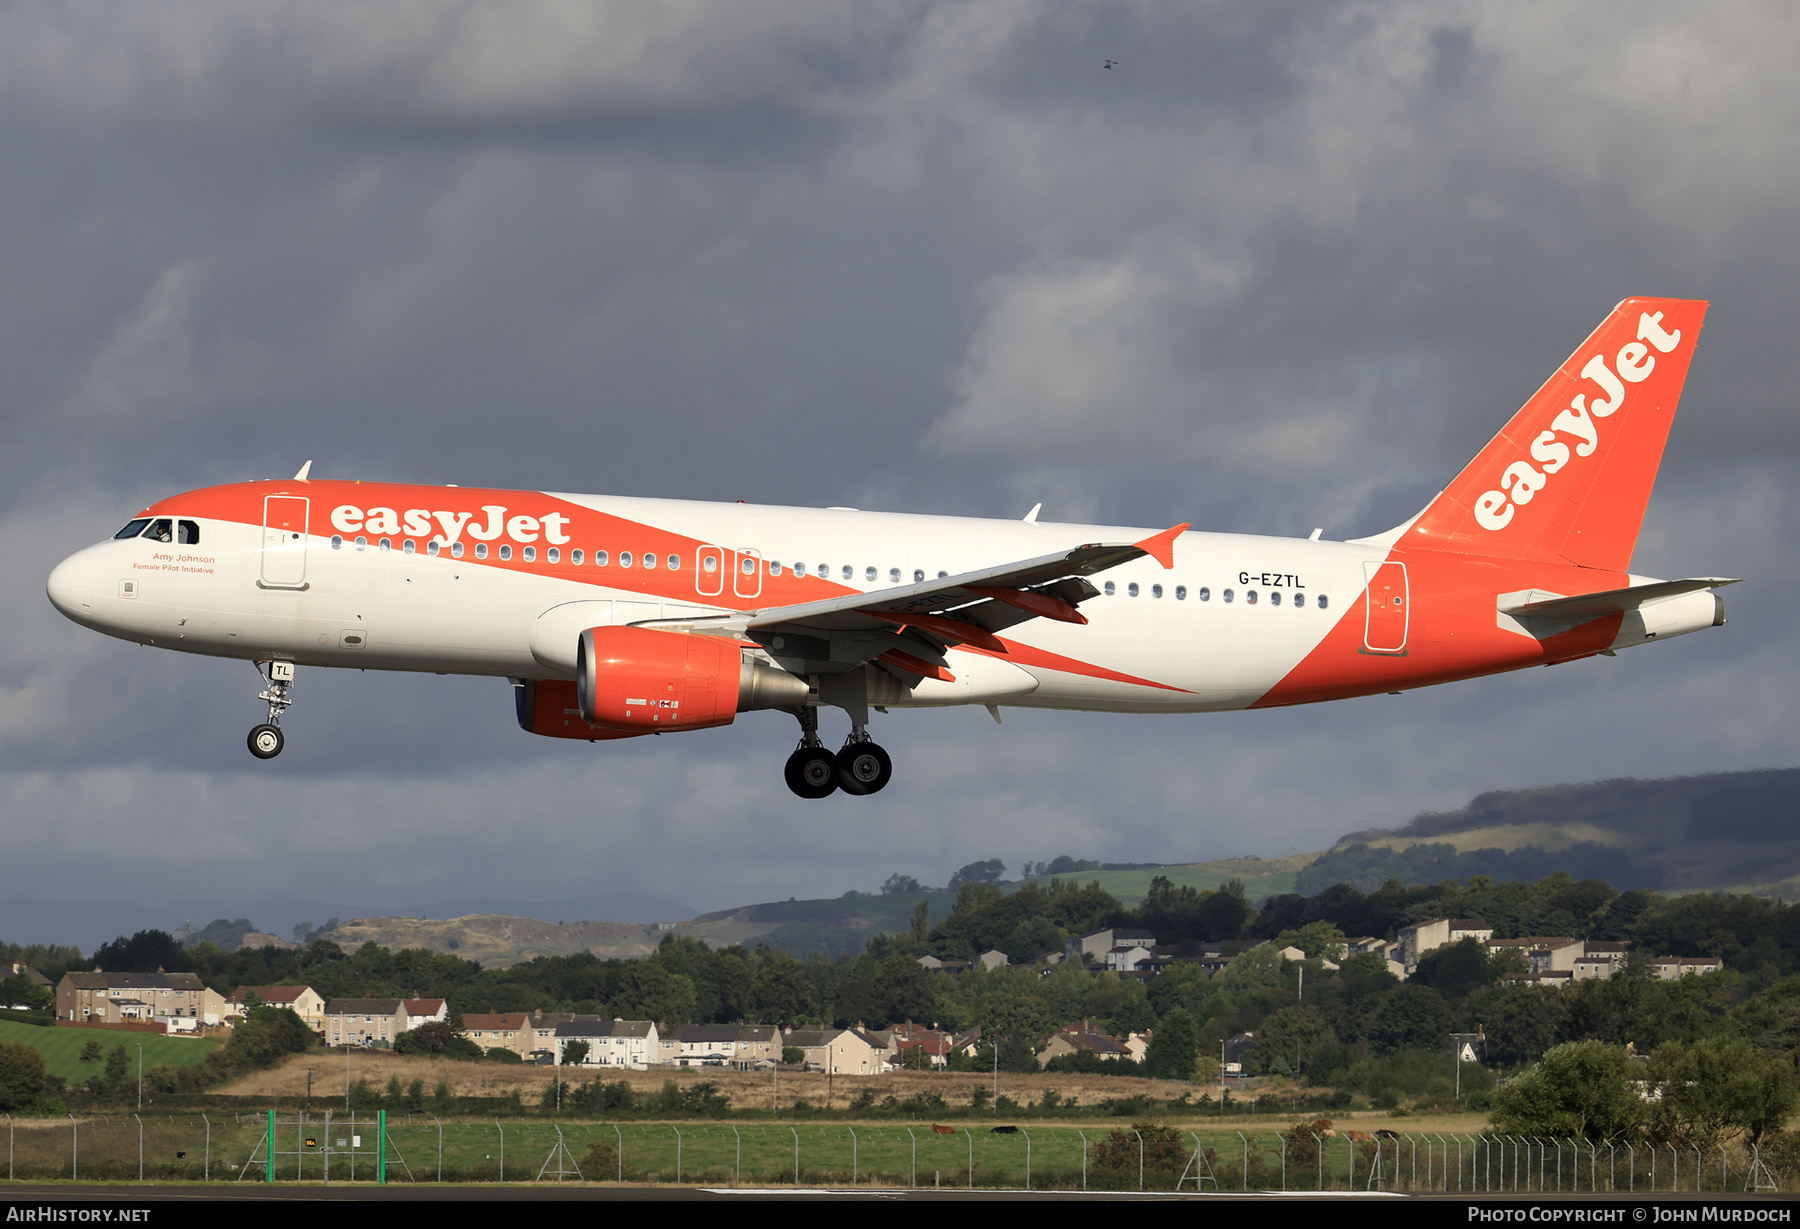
[49,299,1735,799]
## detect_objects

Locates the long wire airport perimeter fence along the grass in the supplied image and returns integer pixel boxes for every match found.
[5,1110,1793,1195]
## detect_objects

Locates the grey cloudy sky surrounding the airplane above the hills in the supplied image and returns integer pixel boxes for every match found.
[0,0,1800,945]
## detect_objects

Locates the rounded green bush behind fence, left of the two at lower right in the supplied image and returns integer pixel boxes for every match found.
[1492,1042,1643,1143]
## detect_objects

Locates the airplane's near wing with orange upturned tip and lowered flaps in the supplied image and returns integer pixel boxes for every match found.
[651,525,1188,682]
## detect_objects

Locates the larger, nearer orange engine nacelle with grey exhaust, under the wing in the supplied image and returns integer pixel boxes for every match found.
[576,626,808,734]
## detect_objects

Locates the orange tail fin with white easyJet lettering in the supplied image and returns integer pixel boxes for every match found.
[1400,299,1706,572]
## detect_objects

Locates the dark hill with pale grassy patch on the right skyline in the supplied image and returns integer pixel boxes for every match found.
[1294,768,1800,896]
